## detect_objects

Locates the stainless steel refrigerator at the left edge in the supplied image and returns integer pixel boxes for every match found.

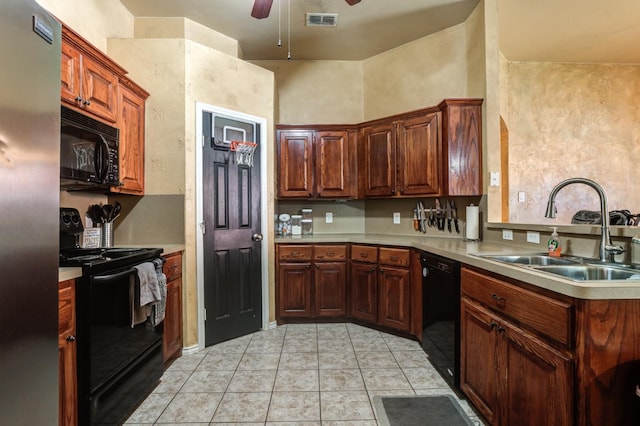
[0,0,61,425]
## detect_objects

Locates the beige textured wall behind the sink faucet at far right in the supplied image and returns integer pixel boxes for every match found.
[501,62,640,224]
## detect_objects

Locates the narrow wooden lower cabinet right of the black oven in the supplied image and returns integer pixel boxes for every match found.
[162,252,182,363]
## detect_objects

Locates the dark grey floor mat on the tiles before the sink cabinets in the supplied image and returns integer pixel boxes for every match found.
[374,395,473,426]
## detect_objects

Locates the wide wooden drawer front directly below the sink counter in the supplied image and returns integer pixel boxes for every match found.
[460,268,573,348]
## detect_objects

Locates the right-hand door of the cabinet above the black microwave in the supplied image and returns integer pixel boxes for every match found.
[81,55,118,122]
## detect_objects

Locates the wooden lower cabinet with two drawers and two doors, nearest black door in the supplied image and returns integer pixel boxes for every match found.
[276,244,347,322]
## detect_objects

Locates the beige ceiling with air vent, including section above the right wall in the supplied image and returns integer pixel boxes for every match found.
[120,0,640,64]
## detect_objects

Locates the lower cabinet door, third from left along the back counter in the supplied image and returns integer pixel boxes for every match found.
[349,262,378,323]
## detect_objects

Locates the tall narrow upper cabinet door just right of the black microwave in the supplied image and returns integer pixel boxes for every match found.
[112,85,145,195]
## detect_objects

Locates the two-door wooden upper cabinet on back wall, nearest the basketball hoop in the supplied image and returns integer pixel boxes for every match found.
[277,126,357,198]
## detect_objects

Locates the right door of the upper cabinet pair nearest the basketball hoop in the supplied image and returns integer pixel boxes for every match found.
[314,130,357,198]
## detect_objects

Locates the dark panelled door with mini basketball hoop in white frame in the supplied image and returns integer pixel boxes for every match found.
[202,112,262,345]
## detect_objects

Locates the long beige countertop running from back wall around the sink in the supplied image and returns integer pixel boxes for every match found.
[275,234,640,300]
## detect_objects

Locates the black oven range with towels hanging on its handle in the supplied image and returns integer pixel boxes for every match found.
[60,208,162,425]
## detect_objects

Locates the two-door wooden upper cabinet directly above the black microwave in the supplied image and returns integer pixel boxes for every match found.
[60,25,126,123]
